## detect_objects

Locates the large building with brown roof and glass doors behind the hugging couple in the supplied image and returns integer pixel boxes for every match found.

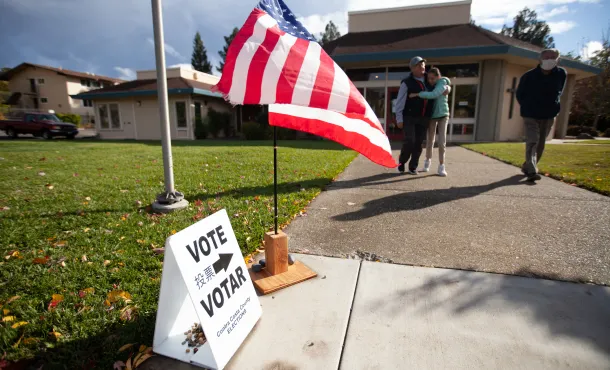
[324,1,599,142]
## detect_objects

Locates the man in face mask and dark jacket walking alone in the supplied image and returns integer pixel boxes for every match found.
[517,49,567,181]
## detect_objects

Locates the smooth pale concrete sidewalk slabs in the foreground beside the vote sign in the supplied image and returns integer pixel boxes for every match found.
[141,255,610,370]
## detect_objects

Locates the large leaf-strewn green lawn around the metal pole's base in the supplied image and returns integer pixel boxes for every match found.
[0,140,356,369]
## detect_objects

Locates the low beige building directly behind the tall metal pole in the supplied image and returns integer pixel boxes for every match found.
[72,67,237,140]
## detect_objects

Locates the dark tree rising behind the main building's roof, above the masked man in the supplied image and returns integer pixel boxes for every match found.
[500,7,555,48]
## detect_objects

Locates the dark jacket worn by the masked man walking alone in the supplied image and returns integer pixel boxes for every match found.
[517,66,567,119]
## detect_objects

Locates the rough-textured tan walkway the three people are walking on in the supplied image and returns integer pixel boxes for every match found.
[286,147,610,284]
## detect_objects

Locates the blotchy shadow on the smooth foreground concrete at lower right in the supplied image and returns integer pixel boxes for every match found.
[367,268,610,356]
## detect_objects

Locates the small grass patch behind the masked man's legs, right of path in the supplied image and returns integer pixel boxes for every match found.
[463,143,610,195]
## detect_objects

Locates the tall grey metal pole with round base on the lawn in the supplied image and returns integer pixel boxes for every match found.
[152,0,188,213]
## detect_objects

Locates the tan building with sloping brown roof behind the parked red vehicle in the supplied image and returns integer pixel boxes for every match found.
[0,63,124,123]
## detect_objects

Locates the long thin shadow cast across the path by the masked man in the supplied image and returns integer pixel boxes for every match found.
[333,175,532,221]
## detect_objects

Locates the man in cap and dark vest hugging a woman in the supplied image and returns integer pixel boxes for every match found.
[396,57,434,175]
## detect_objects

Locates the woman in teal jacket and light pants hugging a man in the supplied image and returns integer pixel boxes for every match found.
[409,68,451,177]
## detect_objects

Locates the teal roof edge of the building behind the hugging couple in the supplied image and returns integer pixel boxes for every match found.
[332,45,601,75]
